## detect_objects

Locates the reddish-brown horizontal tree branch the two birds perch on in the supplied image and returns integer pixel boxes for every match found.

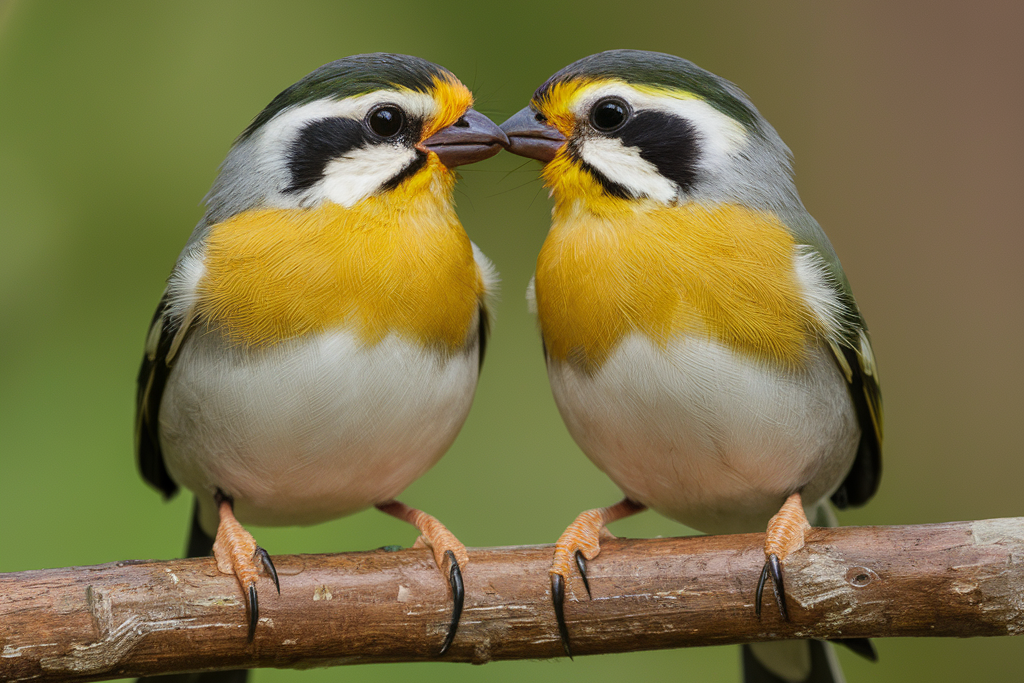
[0,518,1024,683]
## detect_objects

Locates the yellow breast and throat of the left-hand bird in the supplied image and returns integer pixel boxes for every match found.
[198,166,483,352]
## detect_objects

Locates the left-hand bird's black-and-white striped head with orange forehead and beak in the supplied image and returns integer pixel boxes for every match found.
[203,53,507,224]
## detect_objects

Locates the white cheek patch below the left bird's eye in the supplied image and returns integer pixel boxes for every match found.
[317,143,416,207]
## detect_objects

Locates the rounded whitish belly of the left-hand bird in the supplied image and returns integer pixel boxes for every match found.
[160,331,478,531]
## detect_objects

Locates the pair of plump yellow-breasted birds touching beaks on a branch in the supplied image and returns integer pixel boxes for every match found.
[136,50,882,681]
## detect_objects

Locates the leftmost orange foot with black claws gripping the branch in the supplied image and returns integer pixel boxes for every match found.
[213,490,281,642]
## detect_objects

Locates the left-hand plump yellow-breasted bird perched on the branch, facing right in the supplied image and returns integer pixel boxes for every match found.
[135,53,507,679]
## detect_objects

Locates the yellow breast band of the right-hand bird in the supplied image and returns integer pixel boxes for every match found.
[537,202,817,371]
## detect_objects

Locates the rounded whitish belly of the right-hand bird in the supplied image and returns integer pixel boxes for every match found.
[548,335,860,533]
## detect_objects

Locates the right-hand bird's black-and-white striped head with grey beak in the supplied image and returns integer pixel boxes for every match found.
[502,50,799,214]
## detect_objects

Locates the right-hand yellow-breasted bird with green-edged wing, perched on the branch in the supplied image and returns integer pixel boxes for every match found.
[501,49,883,681]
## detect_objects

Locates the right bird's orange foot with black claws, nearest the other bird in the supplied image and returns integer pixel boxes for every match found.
[549,498,647,659]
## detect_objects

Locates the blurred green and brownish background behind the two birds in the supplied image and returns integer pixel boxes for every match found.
[0,0,1024,683]
